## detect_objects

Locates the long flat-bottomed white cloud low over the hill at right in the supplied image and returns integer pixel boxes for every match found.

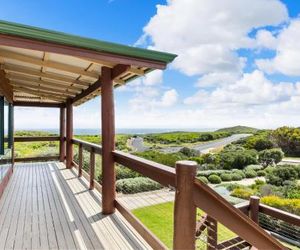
[184,70,294,107]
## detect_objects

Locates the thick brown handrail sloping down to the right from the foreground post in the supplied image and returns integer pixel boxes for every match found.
[194,180,285,249]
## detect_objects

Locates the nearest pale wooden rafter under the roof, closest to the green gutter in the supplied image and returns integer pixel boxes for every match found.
[0,49,99,79]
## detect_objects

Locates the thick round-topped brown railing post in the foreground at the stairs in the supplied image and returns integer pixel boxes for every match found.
[173,161,197,250]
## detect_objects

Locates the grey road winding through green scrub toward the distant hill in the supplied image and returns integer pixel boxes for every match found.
[160,134,251,153]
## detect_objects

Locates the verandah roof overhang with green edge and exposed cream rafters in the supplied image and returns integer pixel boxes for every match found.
[0,21,176,105]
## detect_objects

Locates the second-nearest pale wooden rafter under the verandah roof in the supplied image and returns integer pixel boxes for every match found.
[1,63,90,87]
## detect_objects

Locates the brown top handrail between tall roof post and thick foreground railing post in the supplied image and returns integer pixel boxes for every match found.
[113,150,176,187]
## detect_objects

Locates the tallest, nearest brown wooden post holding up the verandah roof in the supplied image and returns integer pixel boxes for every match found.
[101,67,116,214]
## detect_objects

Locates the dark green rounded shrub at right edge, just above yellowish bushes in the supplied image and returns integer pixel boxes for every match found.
[266,165,299,186]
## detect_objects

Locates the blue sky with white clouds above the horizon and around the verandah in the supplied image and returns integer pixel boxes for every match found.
[0,0,300,129]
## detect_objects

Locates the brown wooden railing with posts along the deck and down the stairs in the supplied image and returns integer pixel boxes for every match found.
[16,137,292,249]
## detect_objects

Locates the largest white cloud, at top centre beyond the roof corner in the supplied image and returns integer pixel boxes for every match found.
[139,0,288,75]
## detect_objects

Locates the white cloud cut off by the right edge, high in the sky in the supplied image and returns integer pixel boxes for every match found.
[256,19,300,76]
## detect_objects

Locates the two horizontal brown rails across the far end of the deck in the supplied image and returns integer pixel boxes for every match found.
[14,136,61,162]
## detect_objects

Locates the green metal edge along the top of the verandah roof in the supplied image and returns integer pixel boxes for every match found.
[0,20,177,64]
